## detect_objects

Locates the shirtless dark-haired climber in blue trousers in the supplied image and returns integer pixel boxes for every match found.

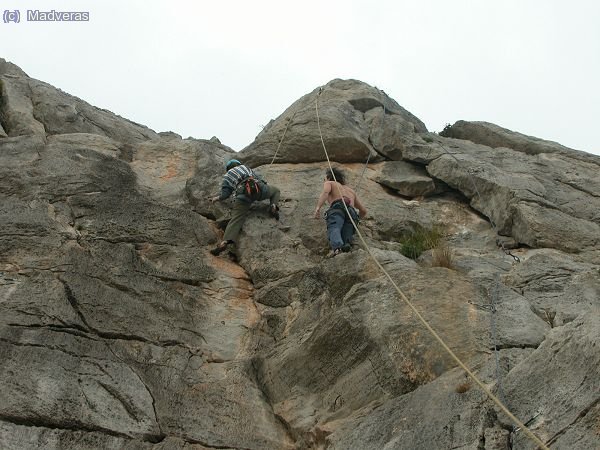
[314,168,367,256]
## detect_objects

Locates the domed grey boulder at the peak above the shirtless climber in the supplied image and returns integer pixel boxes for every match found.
[240,80,427,166]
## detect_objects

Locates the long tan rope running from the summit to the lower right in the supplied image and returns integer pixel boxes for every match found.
[315,88,549,450]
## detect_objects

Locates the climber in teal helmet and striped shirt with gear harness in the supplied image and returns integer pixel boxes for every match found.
[209,159,279,257]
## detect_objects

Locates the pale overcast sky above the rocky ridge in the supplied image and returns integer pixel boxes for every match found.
[0,0,600,154]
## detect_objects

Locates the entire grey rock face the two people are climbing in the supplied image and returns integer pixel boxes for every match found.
[0,60,600,450]
